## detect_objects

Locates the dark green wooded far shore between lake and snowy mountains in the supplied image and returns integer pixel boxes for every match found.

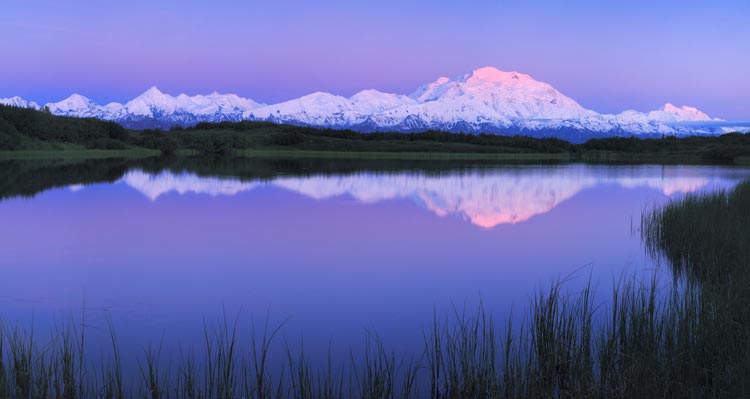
[0,106,750,163]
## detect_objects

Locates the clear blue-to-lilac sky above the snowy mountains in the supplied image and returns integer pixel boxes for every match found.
[0,0,750,120]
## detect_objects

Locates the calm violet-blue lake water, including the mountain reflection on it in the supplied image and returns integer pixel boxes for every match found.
[0,161,750,370]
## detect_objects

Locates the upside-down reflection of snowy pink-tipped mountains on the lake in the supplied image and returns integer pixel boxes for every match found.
[119,165,743,228]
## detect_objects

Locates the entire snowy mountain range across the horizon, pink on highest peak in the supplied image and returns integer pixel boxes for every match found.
[0,67,750,141]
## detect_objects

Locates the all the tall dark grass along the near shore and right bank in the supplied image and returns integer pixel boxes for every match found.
[0,184,750,399]
